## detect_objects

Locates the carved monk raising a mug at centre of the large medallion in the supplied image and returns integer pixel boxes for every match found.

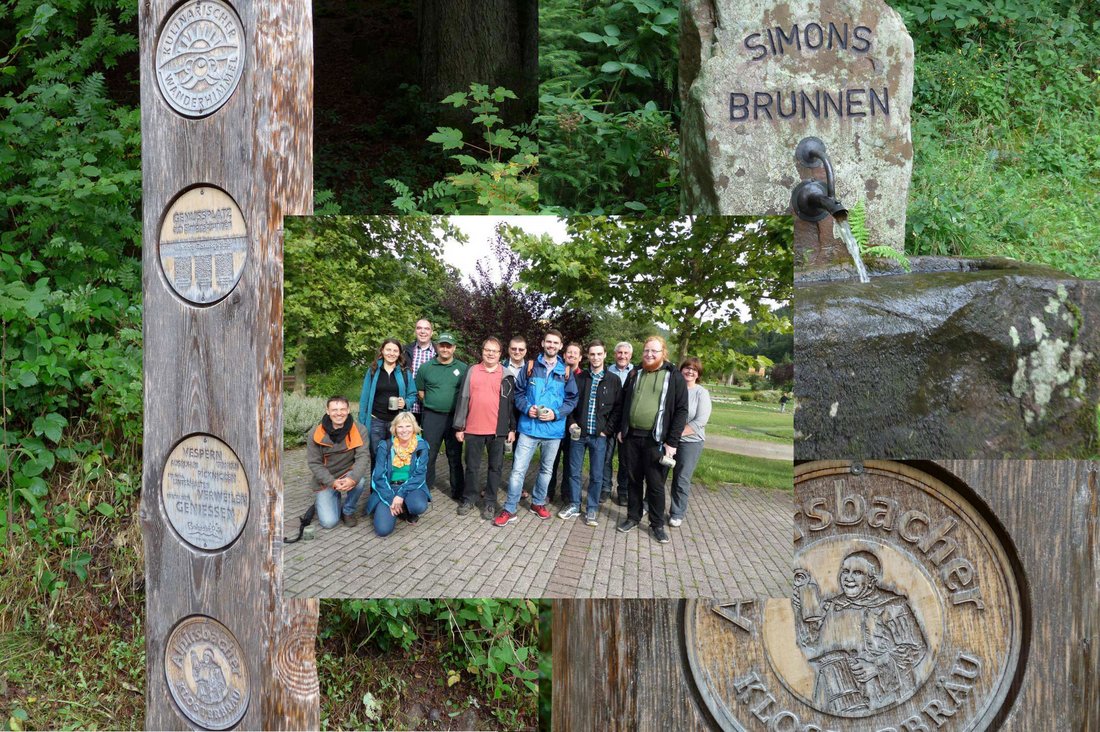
[792,550,928,715]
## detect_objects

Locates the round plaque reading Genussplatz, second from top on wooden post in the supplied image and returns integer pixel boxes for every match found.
[158,186,249,305]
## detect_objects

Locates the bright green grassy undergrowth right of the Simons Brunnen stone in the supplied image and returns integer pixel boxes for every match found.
[893,0,1100,277]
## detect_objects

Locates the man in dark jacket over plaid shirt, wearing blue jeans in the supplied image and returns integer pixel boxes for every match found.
[558,340,623,526]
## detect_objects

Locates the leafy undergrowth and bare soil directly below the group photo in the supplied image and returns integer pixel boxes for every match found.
[318,599,549,730]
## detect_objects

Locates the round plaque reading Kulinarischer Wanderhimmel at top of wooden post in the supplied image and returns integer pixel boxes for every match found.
[156,0,244,117]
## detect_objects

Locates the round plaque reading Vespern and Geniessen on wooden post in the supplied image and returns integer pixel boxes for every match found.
[161,435,249,551]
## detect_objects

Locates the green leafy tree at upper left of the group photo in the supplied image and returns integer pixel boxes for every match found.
[283,216,461,392]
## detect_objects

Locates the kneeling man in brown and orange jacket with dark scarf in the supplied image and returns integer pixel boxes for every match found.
[306,396,371,528]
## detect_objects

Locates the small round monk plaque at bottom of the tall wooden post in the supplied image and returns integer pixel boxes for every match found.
[164,615,250,730]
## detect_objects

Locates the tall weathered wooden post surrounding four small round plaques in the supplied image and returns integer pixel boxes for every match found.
[139,0,319,730]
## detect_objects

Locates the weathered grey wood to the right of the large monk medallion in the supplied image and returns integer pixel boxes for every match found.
[930,460,1100,732]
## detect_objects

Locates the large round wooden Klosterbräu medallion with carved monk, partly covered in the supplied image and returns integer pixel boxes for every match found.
[684,462,1023,732]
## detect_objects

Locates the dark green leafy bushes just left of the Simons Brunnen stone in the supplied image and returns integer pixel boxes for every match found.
[538,0,680,215]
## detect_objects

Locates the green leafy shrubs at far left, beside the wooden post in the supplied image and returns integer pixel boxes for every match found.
[0,1,142,576]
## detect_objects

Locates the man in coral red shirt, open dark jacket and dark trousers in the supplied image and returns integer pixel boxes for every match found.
[454,336,516,521]
